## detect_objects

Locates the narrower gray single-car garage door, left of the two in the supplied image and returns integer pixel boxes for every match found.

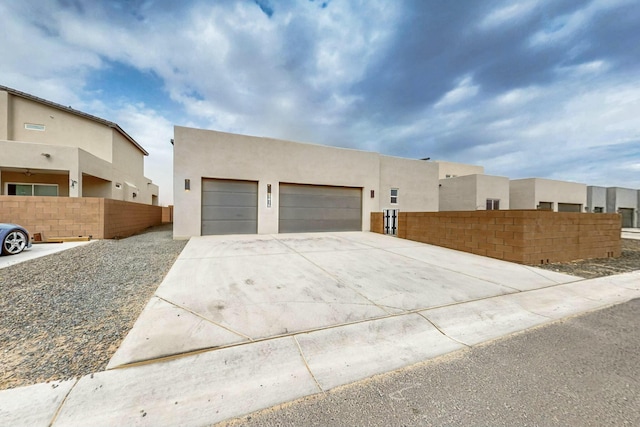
[202,179,258,236]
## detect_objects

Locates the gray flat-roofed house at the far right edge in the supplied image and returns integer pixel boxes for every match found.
[587,186,640,228]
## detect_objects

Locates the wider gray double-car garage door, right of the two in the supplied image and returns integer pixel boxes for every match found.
[279,184,362,233]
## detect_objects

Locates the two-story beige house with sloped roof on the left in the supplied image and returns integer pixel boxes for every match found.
[0,86,158,205]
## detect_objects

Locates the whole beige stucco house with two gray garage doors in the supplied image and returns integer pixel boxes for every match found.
[173,126,438,238]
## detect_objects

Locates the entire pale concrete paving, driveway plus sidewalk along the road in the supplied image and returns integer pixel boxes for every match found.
[0,233,640,426]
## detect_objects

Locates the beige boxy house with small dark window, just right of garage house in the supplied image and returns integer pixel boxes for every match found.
[440,174,509,211]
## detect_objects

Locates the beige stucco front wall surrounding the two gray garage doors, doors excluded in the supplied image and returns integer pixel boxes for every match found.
[173,126,438,239]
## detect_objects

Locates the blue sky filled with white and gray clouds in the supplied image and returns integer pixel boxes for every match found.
[0,0,640,204]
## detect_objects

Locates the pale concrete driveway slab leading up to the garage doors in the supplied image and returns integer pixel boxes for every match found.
[109,232,579,368]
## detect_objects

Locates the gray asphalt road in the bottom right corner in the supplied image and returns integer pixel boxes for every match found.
[223,299,640,426]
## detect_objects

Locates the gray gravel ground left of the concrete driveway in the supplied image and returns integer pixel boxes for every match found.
[0,224,186,390]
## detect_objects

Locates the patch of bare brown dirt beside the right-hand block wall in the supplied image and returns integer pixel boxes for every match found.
[536,239,640,279]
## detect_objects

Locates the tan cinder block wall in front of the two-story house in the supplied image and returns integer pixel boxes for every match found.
[0,196,162,239]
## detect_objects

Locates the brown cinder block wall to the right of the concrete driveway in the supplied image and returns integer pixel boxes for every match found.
[371,210,622,265]
